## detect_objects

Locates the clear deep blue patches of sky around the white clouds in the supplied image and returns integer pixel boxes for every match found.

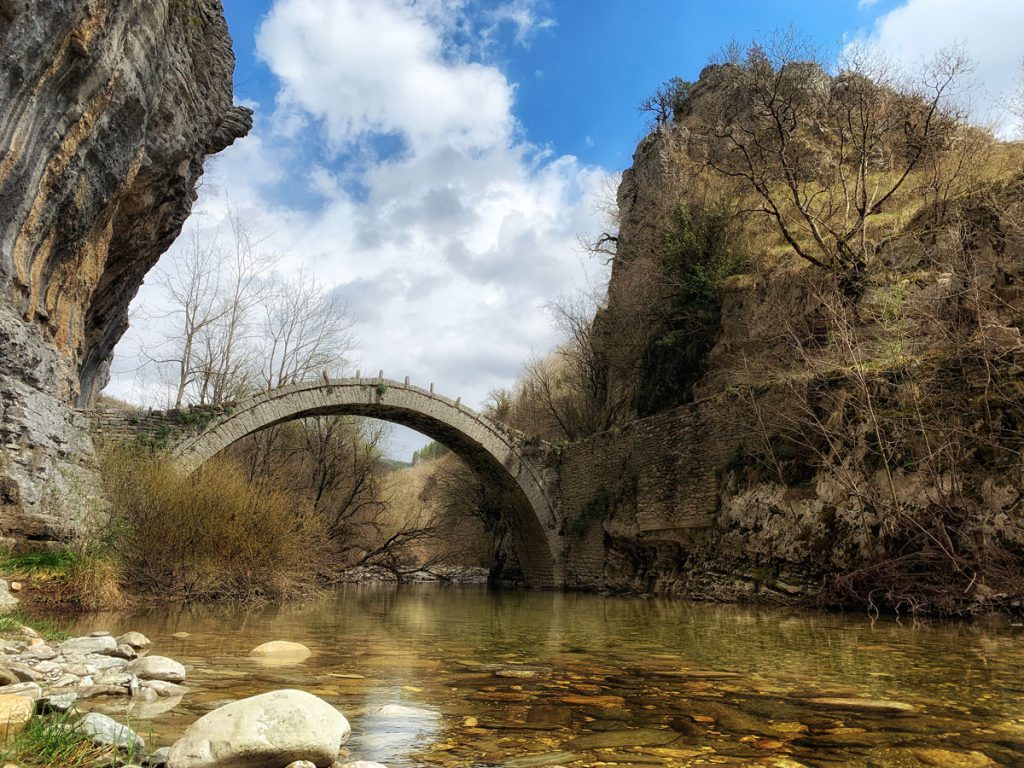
[224,0,899,169]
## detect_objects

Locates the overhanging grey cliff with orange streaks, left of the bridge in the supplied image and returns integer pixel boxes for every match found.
[0,0,252,539]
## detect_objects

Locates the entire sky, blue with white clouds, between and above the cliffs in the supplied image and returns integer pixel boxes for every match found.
[108,0,1024,458]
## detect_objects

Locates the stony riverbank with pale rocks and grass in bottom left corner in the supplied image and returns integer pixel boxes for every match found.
[0,618,389,768]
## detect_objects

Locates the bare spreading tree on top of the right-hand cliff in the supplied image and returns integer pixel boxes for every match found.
[682,33,970,275]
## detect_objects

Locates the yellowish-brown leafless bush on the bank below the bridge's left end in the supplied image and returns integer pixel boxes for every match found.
[103,450,326,600]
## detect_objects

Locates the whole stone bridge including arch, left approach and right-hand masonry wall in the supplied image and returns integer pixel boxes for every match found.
[88,378,758,591]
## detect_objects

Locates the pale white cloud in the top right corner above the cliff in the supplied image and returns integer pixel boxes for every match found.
[856,0,1024,135]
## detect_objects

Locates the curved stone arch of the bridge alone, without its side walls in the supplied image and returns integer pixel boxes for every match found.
[174,384,564,588]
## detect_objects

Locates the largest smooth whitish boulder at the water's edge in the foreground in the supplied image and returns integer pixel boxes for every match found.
[167,689,351,768]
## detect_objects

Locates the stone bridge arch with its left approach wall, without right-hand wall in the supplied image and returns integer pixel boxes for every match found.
[91,377,565,587]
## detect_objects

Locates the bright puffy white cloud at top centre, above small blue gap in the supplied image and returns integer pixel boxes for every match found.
[256,0,513,152]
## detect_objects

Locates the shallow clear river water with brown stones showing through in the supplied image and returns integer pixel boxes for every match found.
[66,585,1024,768]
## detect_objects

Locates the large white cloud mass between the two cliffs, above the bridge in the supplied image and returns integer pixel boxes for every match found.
[114,0,608,460]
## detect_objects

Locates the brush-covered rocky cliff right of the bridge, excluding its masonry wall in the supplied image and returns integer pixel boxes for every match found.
[492,35,1024,612]
